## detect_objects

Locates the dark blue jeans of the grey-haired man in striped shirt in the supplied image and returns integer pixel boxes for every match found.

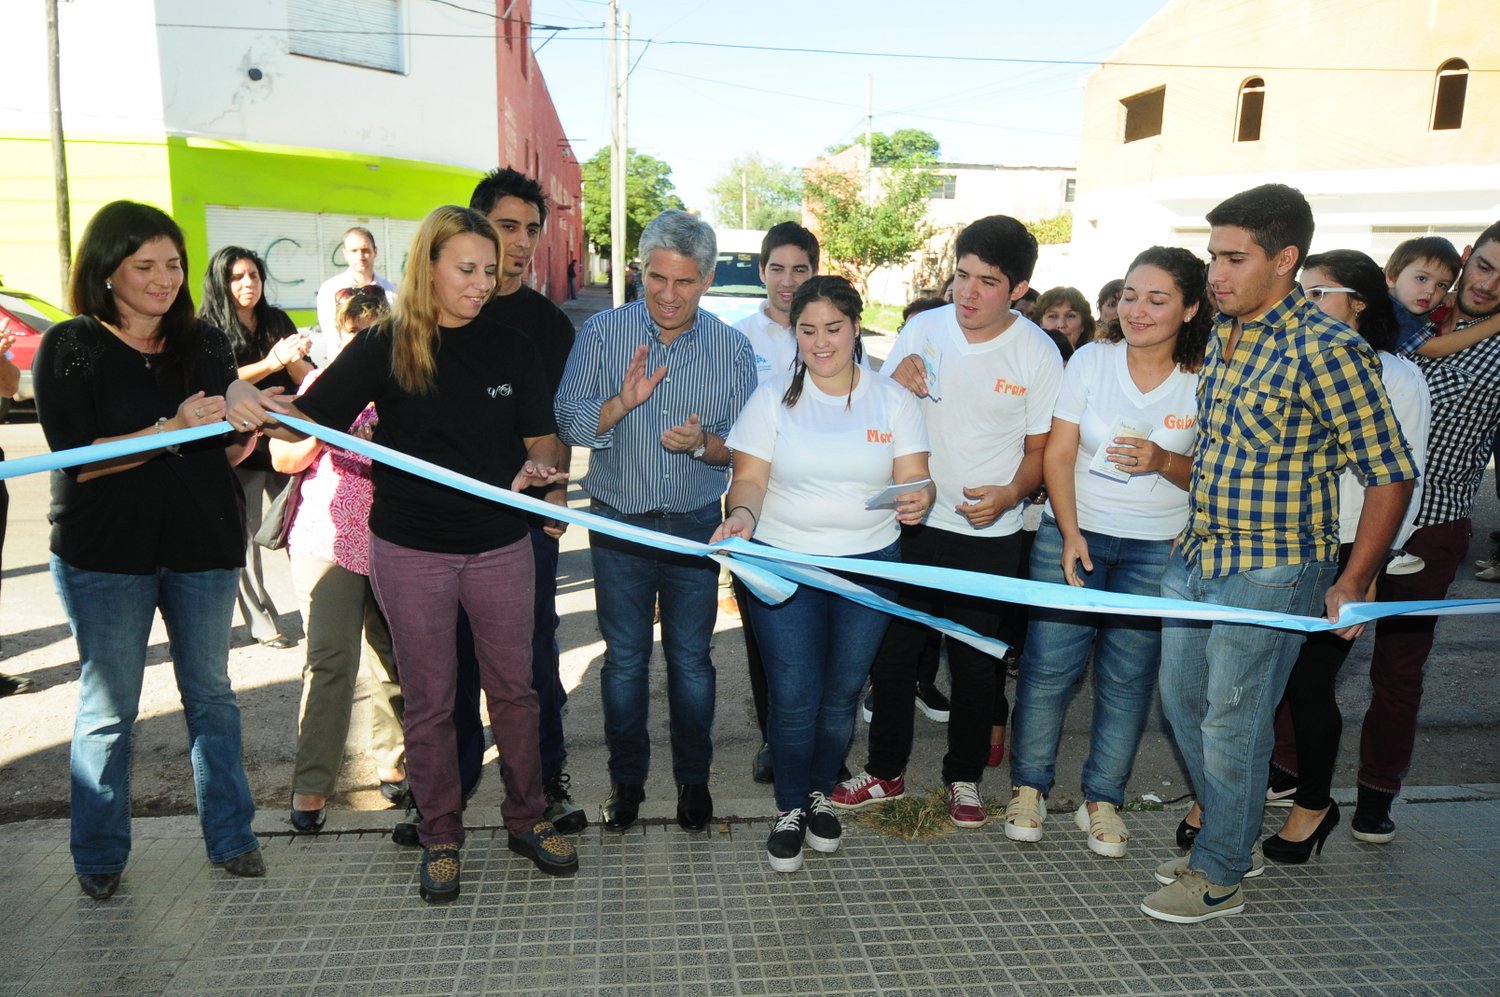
[590,499,722,784]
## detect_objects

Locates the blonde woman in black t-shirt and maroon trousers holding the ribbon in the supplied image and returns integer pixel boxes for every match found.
[230,207,578,903]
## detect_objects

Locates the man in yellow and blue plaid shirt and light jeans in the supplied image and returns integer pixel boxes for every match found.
[1142,184,1416,924]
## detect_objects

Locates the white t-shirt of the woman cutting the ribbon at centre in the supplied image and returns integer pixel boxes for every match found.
[729,370,927,556]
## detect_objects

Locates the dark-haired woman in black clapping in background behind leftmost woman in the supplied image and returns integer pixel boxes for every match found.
[198,246,312,649]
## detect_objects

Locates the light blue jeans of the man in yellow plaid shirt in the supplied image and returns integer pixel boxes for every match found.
[1161,550,1338,886]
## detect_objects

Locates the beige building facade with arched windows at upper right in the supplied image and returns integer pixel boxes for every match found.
[1070,0,1500,292]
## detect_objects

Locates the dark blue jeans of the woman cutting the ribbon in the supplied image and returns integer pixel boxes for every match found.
[747,540,902,811]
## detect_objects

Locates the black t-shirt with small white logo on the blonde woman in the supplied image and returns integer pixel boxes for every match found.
[297,315,557,555]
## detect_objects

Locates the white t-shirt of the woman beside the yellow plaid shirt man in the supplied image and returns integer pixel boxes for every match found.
[1047,342,1199,540]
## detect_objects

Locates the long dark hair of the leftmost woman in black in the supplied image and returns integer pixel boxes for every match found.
[68,201,201,388]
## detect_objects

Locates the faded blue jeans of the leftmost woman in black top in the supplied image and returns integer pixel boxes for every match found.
[51,555,260,873]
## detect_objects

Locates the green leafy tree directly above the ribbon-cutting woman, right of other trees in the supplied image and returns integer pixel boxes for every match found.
[804,162,935,295]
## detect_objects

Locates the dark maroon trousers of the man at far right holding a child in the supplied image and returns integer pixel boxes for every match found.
[1359,519,1472,793]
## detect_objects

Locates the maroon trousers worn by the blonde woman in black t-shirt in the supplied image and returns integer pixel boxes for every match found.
[371,537,546,846]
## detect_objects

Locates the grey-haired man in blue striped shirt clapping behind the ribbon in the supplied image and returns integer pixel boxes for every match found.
[554,211,756,831]
